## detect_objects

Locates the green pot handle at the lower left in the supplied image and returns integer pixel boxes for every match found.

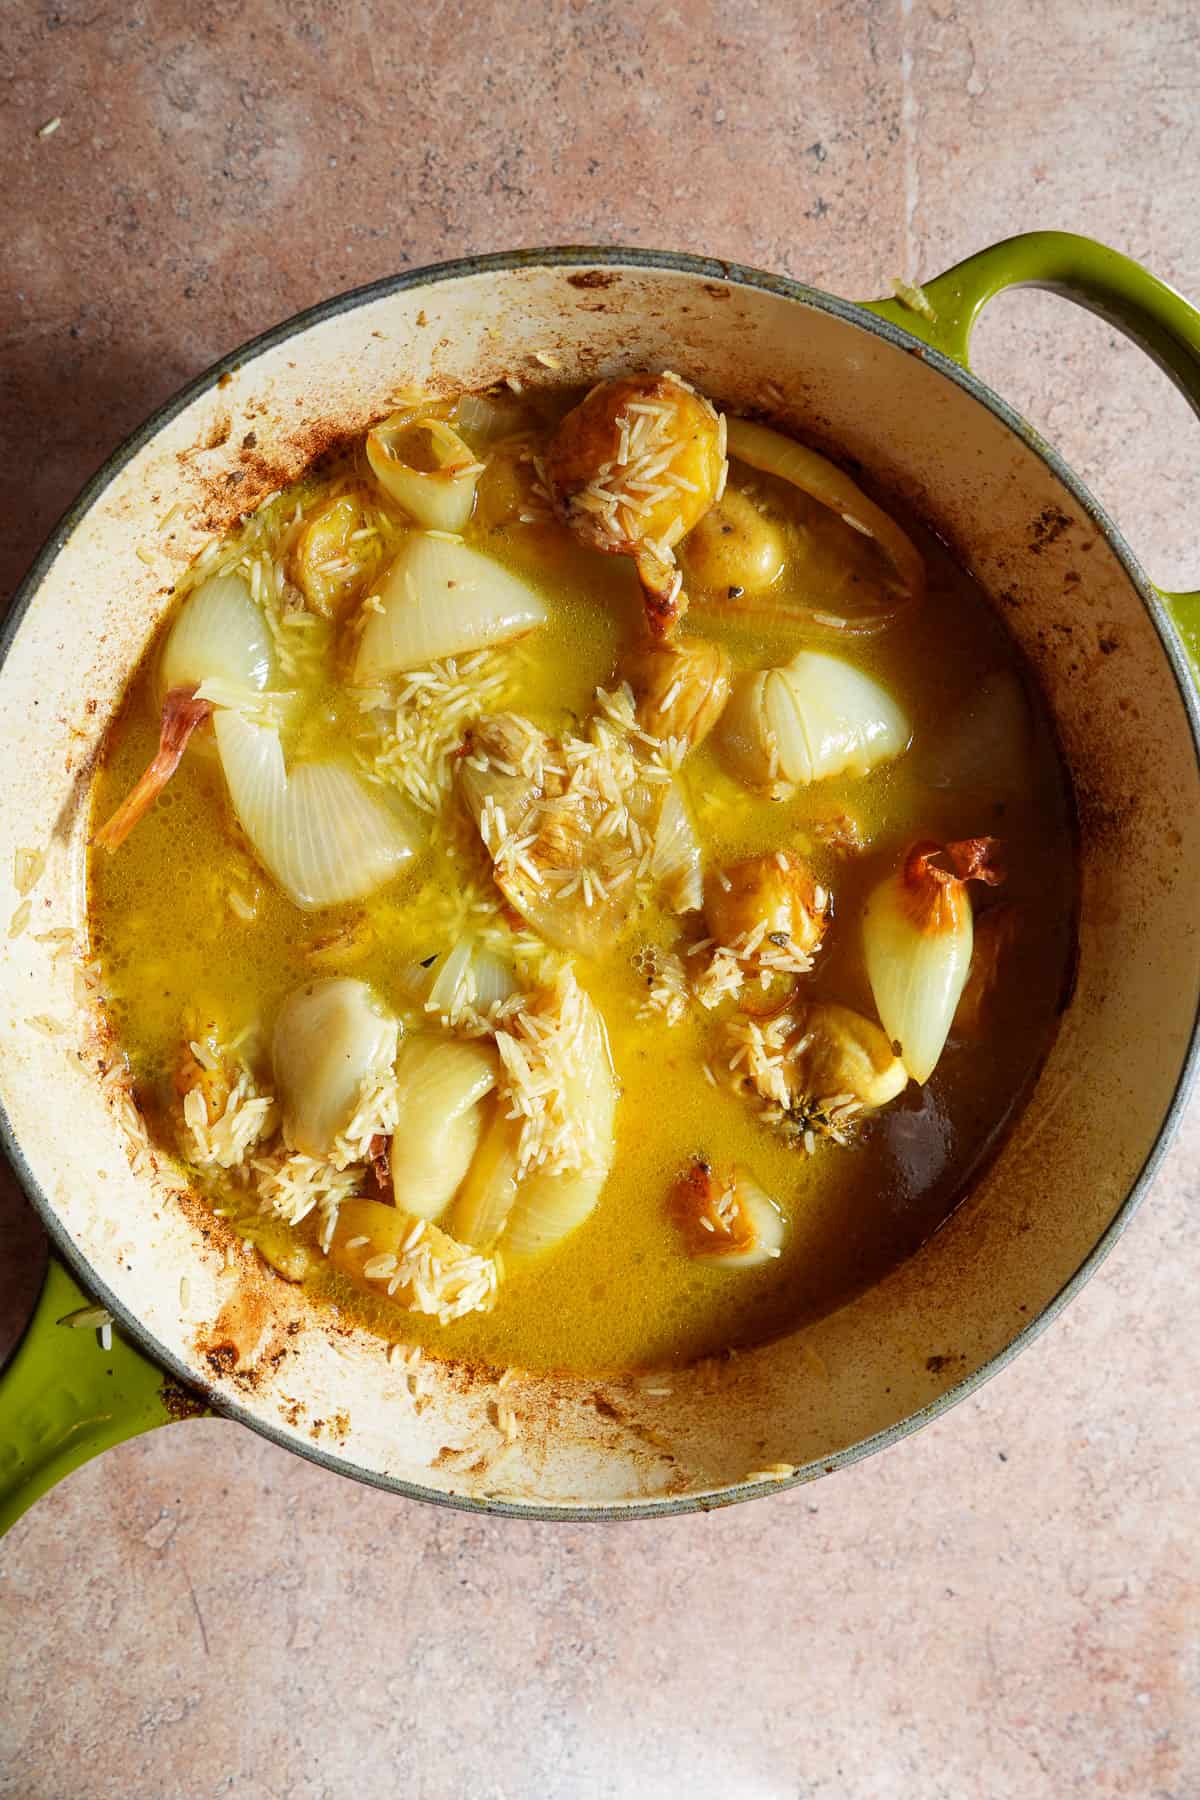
[0,1255,205,1535]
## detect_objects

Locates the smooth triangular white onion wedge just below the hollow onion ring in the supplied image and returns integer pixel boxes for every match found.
[354,531,547,688]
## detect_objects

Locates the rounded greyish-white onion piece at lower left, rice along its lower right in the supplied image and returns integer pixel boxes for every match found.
[272,976,399,1156]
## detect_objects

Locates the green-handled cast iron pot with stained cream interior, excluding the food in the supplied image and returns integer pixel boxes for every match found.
[0,232,1200,1525]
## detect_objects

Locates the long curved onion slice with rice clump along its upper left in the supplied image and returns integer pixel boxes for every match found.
[500,990,617,1262]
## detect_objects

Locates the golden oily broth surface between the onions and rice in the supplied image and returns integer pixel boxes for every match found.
[90,394,1076,1368]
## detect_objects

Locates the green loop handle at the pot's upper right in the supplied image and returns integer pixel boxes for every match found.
[865,230,1200,673]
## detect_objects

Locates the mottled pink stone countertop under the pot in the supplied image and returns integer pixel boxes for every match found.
[0,0,1200,1800]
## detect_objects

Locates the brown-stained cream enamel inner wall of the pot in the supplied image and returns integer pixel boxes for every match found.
[0,263,1200,1508]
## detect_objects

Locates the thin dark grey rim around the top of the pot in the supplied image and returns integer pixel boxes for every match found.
[9,245,1200,1523]
